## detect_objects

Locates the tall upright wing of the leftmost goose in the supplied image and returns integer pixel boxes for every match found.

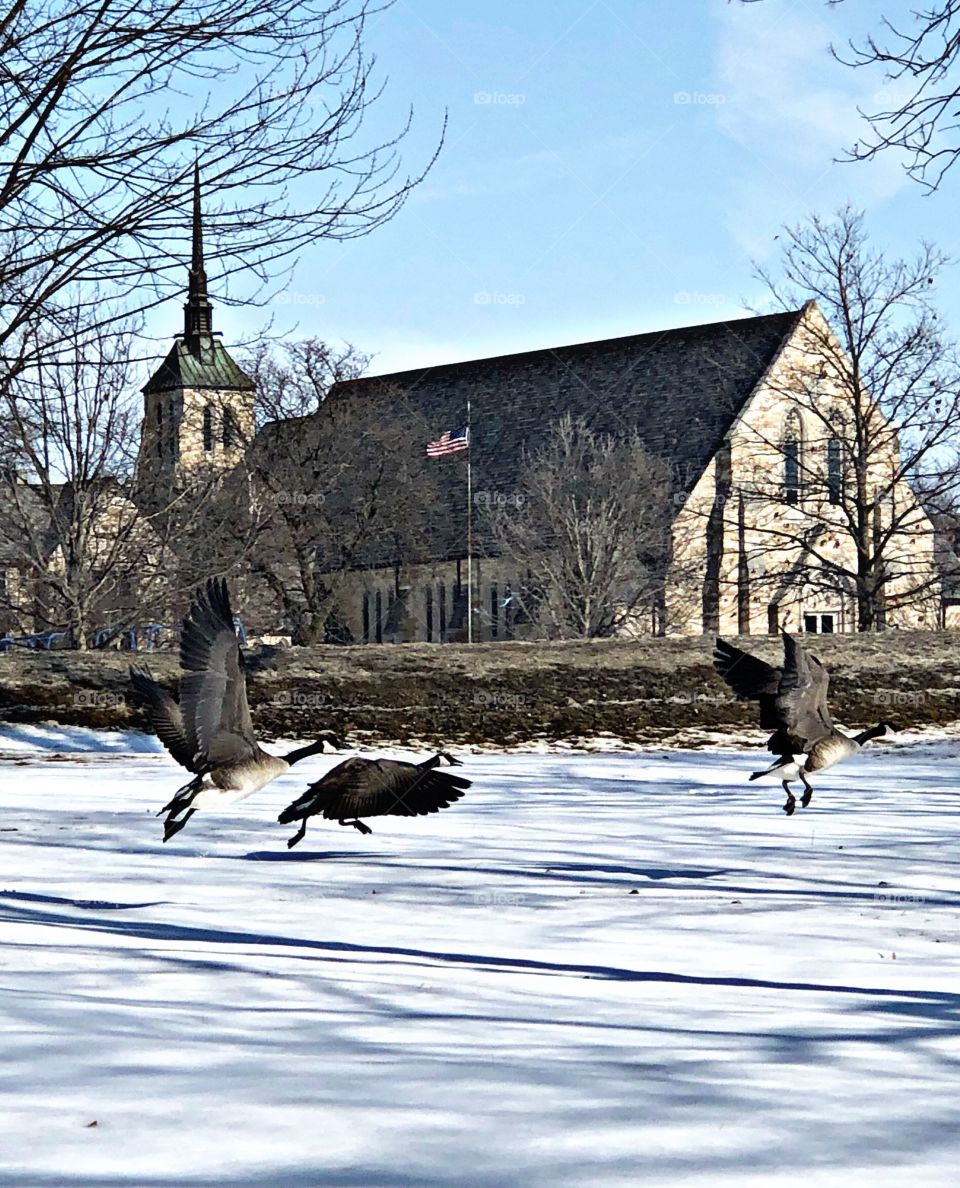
[179,579,259,771]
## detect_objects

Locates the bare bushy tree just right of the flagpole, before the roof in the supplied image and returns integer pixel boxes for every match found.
[486,413,671,639]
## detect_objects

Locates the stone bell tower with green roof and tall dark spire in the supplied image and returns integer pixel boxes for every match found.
[138,163,254,498]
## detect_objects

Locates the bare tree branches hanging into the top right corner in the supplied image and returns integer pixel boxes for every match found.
[741,0,960,190]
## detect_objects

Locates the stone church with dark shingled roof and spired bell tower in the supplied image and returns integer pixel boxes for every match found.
[131,176,958,643]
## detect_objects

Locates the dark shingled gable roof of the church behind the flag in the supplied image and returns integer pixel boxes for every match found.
[329,309,803,557]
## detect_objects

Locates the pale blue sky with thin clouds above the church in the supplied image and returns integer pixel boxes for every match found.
[171,0,960,373]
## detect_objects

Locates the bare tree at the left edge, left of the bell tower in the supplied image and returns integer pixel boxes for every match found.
[0,301,184,649]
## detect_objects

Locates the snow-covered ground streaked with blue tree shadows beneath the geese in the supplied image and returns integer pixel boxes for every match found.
[0,728,960,1188]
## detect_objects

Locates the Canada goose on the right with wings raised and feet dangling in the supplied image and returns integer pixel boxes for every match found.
[713,631,898,816]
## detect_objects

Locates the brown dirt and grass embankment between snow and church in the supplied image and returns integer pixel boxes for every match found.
[0,632,960,746]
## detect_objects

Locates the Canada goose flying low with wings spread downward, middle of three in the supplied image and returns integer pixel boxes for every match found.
[278,751,470,849]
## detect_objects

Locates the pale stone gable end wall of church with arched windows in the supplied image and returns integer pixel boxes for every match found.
[668,305,943,634]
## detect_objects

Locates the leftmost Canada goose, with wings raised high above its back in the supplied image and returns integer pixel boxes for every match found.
[130,579,342,841]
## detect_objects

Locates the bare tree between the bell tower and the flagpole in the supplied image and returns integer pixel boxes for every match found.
[234,340,435,644]
